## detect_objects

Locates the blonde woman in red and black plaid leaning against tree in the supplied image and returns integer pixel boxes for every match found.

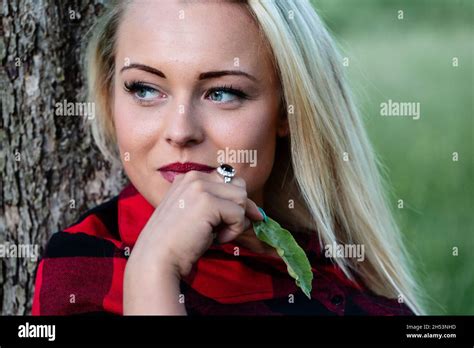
[33,0,422,315]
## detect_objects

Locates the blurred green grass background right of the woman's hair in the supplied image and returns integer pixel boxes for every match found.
[312,0,474,315]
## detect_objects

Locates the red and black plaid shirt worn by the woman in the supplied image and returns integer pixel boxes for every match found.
[32,185,413,315]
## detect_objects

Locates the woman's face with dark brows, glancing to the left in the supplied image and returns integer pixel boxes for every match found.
[113,1,287,206]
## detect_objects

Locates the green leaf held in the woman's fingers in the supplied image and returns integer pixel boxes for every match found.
[253,215,313,299]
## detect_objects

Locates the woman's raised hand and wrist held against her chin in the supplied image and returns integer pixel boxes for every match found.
[124,171,263,314]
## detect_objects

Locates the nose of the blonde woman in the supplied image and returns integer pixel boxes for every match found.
[164,98,204,147]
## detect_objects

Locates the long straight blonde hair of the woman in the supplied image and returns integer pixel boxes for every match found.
[83,0,423,314]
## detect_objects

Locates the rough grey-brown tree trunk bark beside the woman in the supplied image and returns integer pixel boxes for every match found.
[0,0,124,315]
